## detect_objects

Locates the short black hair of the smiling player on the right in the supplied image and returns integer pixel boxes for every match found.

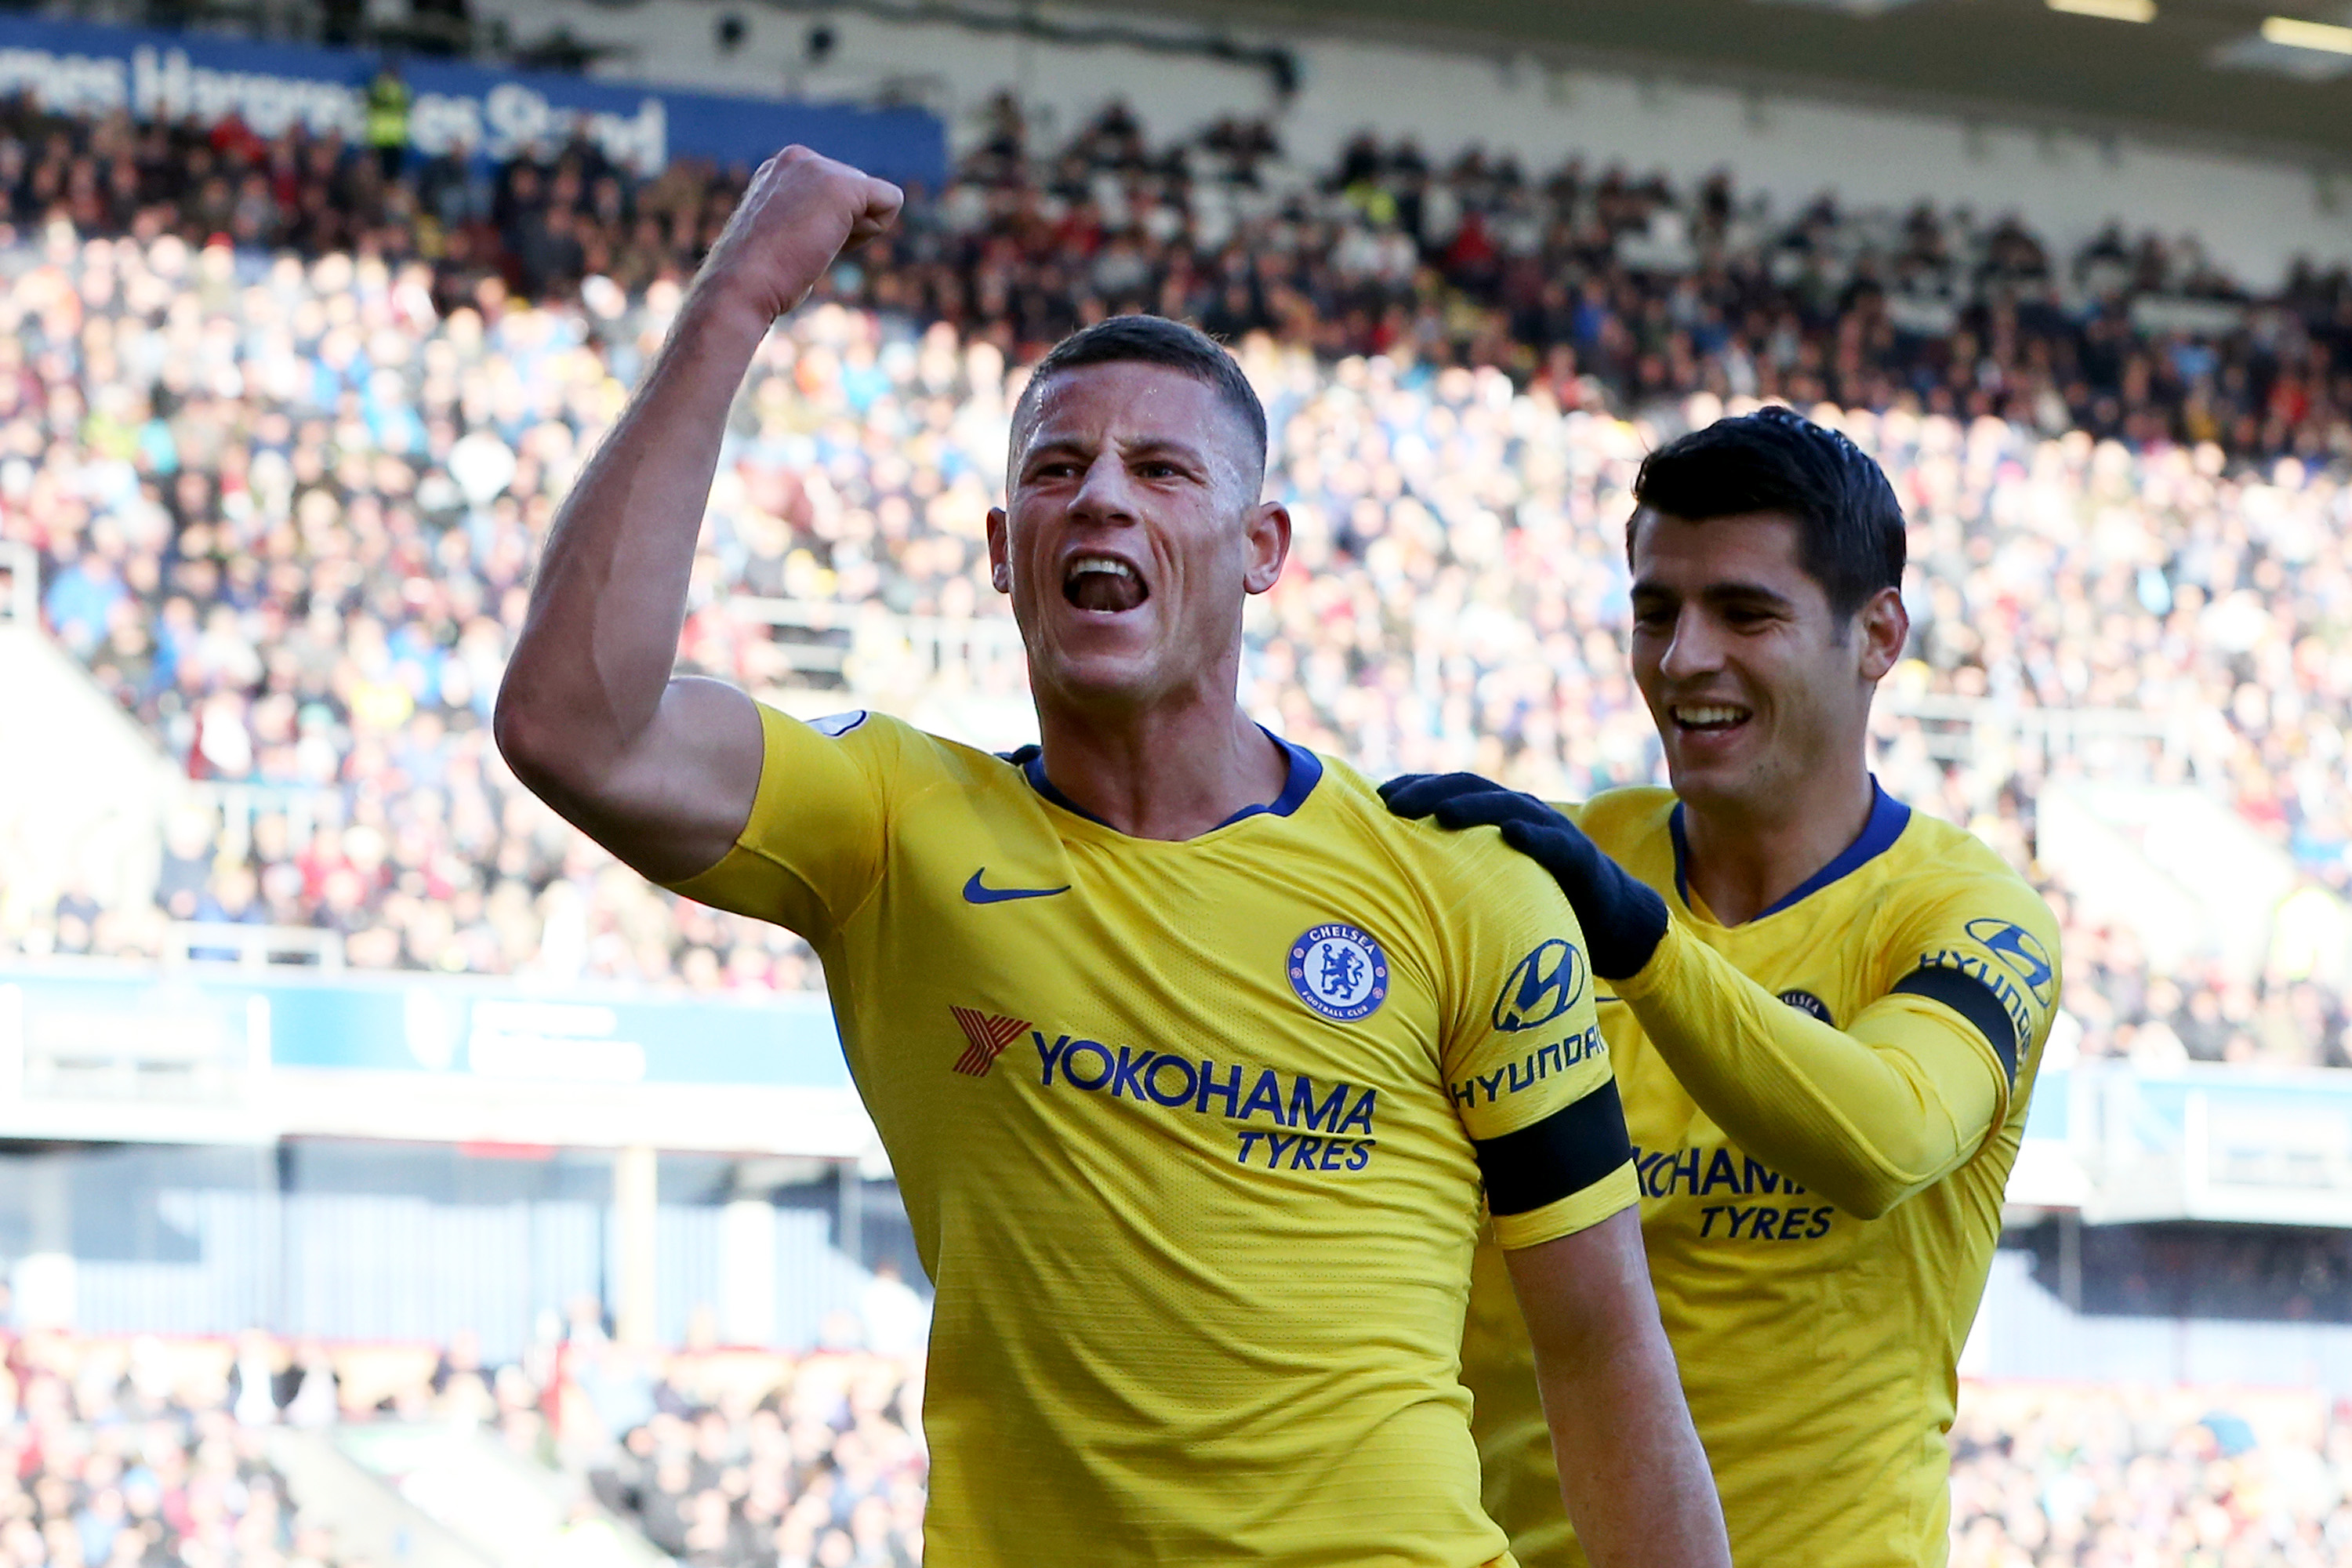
[1625,407,1907,619]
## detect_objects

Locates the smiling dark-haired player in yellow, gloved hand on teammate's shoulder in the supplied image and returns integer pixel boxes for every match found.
[1383,409,2060,1568]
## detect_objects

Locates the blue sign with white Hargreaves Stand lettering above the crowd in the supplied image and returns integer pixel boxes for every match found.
[0,16,948,186]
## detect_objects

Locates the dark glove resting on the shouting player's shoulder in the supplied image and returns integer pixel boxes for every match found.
[1381,774,1668,980]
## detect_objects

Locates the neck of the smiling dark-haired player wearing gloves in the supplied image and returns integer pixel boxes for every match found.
[1682,757,1875,926]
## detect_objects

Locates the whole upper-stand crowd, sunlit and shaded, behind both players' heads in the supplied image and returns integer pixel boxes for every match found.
[0,89,2352,1065]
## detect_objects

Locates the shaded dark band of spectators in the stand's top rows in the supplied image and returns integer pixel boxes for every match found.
[13,96,2352,459]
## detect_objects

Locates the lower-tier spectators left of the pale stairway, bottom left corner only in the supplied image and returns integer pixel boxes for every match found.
[0,1335,362,1568]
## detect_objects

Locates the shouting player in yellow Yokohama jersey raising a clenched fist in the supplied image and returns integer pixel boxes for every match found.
[496,148,1729,1568]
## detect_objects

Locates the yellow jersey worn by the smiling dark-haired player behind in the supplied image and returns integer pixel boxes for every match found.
[1463,787,2058,1568]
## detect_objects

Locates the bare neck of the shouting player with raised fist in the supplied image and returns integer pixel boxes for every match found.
[1037,699,1291,841]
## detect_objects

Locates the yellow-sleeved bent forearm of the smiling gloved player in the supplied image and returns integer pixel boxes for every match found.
[1616,926,2002,1218]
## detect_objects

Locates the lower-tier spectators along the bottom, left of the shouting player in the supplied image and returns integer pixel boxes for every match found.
[0,1316,927,1568]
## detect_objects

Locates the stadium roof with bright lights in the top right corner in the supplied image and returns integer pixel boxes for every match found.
[1110,0,2352,165]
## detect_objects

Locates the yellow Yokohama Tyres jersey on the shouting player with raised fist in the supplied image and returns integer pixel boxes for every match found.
[680,710,1635,1568]
